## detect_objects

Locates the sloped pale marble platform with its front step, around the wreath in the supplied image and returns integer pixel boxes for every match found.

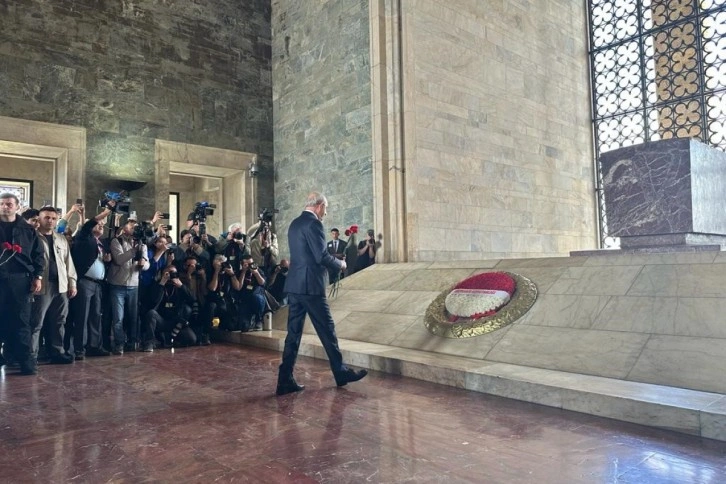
[219,251,726,441]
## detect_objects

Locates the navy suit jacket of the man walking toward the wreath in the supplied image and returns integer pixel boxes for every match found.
[285,211,343,296]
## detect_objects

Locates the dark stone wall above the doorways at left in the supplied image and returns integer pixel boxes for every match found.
[0,0,274,216]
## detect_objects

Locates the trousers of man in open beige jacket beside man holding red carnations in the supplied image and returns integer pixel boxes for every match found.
[31,281,68,358]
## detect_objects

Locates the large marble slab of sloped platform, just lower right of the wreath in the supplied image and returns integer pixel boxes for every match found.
[486,324,649,378]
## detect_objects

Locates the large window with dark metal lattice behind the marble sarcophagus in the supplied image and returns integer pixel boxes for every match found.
[588,0,726,246]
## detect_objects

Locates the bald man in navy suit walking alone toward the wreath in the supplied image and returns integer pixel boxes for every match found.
[276,192,368,395]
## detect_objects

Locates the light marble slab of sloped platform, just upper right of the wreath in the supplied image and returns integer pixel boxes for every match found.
[547,266,642,296]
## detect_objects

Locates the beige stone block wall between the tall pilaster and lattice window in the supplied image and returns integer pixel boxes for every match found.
[402,0,598,261]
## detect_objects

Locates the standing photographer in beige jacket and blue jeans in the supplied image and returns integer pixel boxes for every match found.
[106,216,149,355]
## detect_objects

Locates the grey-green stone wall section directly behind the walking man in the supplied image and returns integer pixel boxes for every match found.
[272,0,373,253]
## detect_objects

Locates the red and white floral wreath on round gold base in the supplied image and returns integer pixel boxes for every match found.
[424,272,537,338]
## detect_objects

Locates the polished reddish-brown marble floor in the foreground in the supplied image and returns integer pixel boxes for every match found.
[0,344,726,483]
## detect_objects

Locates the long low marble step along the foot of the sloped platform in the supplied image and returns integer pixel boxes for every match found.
[215,330,726,441]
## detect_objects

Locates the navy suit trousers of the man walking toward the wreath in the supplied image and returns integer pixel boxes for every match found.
[280,294,346,380]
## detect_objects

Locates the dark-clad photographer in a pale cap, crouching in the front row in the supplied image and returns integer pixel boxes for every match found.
[206,254,241,331]
